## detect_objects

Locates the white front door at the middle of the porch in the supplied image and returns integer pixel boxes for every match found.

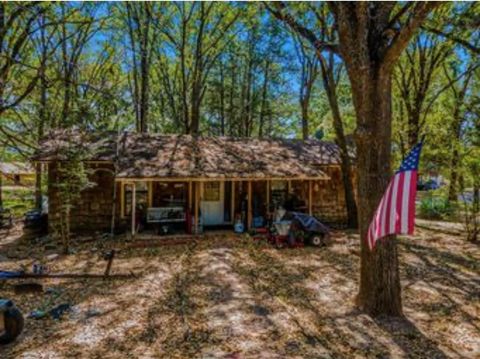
[201,181,225,226]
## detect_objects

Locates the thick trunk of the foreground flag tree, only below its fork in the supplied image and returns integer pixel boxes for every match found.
[350,64,402,316]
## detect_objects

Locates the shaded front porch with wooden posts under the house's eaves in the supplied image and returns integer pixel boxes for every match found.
[116,178,321,235]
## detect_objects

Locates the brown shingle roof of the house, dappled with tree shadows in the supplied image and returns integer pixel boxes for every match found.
[33,131,348,179]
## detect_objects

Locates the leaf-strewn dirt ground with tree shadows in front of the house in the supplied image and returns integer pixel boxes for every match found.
[0,223,480,359]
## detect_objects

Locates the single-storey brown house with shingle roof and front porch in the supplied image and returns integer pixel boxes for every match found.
[33,130,354,232]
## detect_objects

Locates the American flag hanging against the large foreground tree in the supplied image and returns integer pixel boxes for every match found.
[367,141,423,249]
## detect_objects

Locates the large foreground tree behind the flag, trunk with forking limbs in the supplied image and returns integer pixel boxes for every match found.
[267,2,439,316]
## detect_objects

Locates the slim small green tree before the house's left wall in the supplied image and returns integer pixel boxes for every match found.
[54,146,92,254]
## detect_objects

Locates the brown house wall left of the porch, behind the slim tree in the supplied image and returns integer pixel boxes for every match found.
[48,163,114,232]
